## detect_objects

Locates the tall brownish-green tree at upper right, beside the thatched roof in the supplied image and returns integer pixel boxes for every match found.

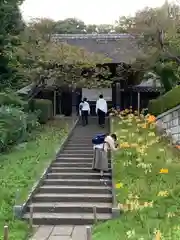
[116,1,180,91]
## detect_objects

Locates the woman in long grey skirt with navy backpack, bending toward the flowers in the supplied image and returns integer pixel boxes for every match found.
[92,133,118,177]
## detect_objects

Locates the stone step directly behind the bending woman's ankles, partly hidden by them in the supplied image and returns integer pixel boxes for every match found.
[49,166,111,173]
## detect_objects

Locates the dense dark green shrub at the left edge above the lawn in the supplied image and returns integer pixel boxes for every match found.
[0,106,37,152]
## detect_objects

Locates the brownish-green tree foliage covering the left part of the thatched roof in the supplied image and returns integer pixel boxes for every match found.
[15,25,111,86]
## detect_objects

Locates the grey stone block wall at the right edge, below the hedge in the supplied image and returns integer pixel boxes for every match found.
[157,105,180,143]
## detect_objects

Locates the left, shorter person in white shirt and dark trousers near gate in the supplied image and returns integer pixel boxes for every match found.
[79,98,90,126]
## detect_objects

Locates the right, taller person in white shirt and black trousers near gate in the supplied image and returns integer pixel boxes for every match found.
[96,94,108,127]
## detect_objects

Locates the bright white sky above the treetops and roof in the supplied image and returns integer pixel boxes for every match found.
[21,0,170,24]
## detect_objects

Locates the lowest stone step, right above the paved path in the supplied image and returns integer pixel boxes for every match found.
[24,213,112,225]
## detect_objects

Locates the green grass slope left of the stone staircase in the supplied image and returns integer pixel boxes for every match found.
[0,120,69,240]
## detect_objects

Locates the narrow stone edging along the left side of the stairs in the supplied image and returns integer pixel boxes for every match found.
[13,118,79,219]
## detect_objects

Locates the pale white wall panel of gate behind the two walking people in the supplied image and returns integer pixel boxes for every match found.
[82,88,112,101]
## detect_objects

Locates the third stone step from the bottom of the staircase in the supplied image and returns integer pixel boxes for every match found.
[32,193,112,203]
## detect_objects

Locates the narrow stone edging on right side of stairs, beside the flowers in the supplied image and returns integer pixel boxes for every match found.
[109,117,120,218]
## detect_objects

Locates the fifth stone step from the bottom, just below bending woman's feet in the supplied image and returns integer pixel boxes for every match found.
[44,179,112,187]
